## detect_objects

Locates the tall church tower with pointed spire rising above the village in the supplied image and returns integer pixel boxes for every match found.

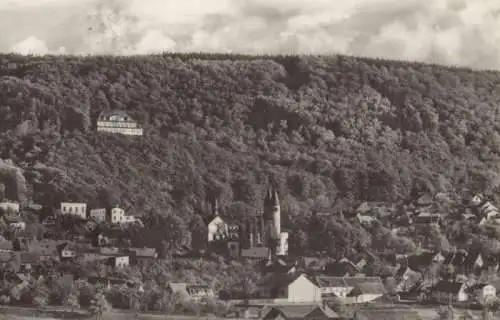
[263,186,281,254]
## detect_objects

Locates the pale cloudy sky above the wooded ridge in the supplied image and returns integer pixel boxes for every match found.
[0,0,500,70]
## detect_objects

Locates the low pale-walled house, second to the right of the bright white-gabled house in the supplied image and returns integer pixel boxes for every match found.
[344,277,387,303]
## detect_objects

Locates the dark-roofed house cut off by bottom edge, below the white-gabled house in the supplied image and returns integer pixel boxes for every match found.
[260,304,340,320]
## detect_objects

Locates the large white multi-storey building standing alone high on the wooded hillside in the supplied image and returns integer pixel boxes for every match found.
[97,110,143,136]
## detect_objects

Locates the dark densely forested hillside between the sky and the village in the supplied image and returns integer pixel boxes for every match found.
[0,54,500,228]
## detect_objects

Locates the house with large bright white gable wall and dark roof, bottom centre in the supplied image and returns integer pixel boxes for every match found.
[258,273,321,303]
